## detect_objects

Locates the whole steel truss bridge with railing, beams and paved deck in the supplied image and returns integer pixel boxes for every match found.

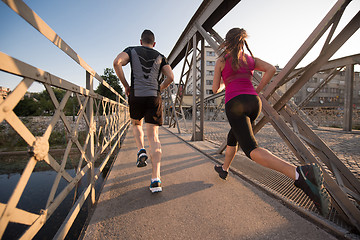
[0,0,360,239]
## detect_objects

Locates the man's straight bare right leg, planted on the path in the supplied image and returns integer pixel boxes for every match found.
[146,123,161,179]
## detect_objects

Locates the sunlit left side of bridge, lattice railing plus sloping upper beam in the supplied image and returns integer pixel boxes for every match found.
[0,0,130,239]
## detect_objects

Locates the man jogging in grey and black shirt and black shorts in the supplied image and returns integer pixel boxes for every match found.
[114,30,174,193]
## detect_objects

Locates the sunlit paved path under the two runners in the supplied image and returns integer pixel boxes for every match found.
[84,128,335,240]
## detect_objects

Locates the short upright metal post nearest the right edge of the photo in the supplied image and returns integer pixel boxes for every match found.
[343,65,354,131]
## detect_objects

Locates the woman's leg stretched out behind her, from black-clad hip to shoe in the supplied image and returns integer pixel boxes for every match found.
[224,95,330,216]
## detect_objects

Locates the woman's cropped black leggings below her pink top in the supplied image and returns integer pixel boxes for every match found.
[225,94,261,158]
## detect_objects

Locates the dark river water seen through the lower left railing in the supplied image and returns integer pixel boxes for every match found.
[0,162,112,239]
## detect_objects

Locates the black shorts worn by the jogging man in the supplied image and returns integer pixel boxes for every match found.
[129,94,163,126]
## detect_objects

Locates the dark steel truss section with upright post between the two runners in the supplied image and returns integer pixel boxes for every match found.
[168,0,240,141]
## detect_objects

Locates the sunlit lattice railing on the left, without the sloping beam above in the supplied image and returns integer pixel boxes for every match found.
[0,53,129,239]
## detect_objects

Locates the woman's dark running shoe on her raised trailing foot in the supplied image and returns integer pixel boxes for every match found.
[294,163,330,217]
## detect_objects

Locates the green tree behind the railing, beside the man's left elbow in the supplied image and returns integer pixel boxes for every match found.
[95,68,125,101]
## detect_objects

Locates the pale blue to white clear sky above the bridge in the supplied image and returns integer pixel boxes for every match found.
[0,0,360,92]
